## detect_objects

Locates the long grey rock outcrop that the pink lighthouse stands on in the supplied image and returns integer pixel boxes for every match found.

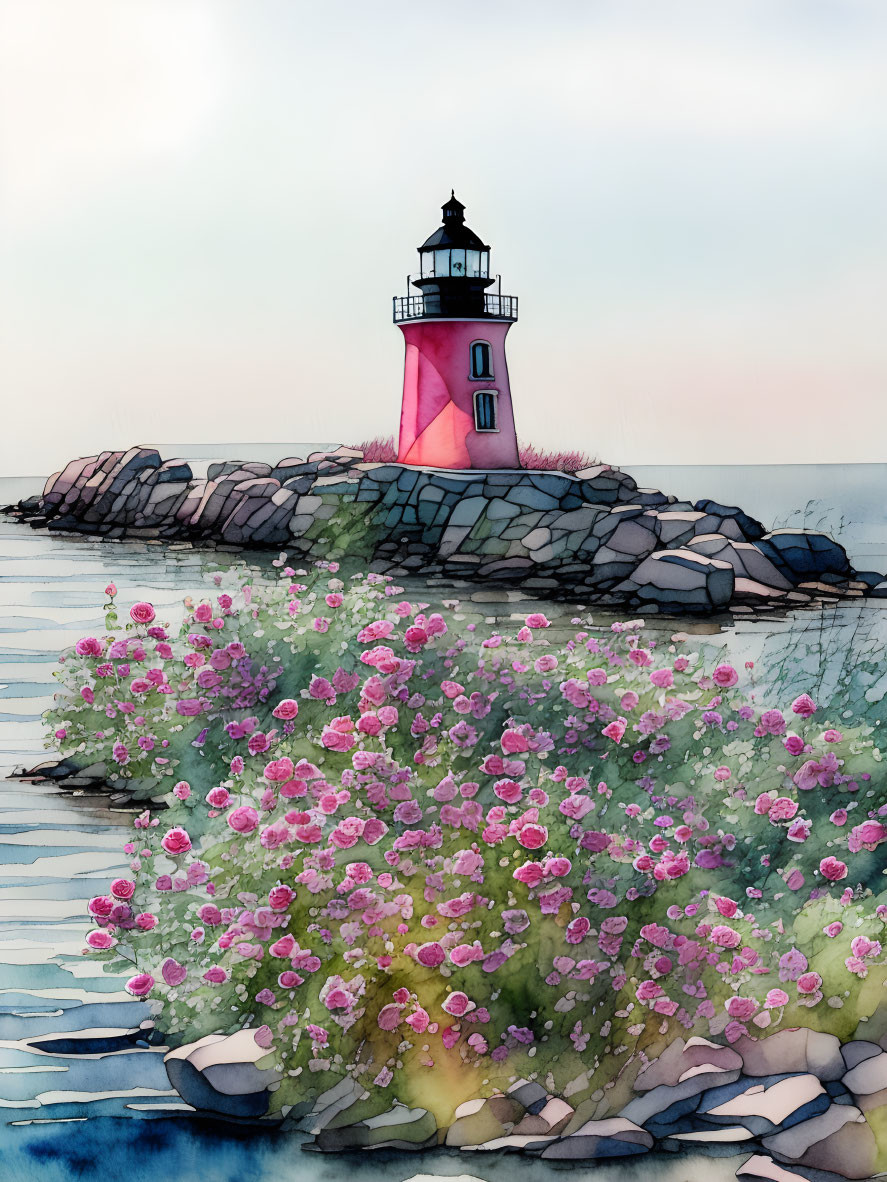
[7,448,887,615]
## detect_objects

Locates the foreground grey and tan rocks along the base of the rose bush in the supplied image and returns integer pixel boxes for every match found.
[166,1027,887,1182]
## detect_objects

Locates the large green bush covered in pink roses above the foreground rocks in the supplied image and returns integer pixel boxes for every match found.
[51,563,887,1124]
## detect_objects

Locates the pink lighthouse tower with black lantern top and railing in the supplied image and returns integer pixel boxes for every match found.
[394,194,519,468]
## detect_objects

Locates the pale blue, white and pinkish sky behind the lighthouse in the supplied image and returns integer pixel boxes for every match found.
[0,0,887,475]
